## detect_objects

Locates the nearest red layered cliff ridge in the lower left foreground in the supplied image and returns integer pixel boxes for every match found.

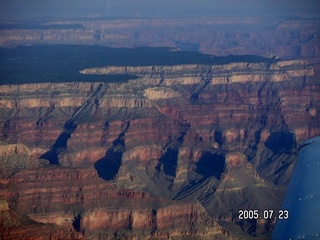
[0,167,227,239]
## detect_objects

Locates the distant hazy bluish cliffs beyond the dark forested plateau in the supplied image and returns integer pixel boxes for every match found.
[0,17,320,57]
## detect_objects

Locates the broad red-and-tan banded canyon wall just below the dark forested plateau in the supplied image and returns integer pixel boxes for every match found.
[0,61,319,166]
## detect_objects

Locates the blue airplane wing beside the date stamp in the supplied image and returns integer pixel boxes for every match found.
[272,136,320,240]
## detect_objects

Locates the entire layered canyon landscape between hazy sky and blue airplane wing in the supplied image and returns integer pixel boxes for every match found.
[0,15,320,239]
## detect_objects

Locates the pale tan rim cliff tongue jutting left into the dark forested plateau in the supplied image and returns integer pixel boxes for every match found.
[80,60,314,85]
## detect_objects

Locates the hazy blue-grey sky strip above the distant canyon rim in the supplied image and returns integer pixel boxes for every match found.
[0,0,320,22]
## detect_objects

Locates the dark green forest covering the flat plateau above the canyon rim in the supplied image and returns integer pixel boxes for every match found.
[0,45,276,84]
